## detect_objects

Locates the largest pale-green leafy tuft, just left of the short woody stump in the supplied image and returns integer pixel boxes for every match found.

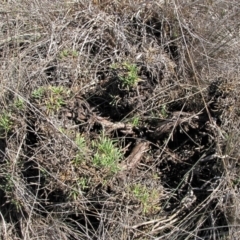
[92,135,123,173]
